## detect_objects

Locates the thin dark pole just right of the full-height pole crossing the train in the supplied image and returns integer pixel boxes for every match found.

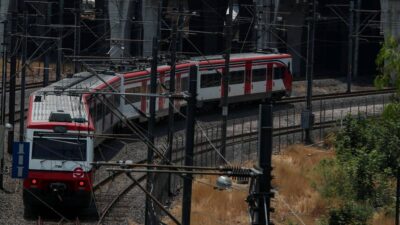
[167,19,180,194]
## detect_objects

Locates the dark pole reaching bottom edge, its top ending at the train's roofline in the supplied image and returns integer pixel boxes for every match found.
[182,66,197,225]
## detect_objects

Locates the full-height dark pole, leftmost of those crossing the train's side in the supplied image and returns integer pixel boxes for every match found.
[144,0,162,225]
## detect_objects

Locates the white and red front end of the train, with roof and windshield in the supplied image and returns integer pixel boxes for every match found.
[23,91,94,214]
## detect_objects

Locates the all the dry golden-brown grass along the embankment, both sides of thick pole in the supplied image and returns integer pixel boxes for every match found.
[160,145,393,225]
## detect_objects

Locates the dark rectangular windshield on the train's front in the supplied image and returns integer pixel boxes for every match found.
[32,137,87,161]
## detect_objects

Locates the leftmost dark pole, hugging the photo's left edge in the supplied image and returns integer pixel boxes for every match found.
[0,20,7,125]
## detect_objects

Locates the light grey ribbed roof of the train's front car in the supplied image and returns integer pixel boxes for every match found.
[28,72,119,127]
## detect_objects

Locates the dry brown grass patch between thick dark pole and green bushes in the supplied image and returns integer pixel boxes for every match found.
[272,145,334,224]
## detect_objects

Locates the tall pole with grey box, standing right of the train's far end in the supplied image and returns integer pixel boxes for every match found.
[301,0,318,144]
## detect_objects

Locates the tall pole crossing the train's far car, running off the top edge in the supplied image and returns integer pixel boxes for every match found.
[220,0,233,163]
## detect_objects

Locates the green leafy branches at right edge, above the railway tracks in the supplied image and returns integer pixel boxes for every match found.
[375,37,400,90]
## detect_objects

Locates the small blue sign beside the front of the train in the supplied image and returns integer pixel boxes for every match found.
[11,142,29,179]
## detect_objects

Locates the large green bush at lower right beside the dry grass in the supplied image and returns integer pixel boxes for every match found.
[315,113,400,225]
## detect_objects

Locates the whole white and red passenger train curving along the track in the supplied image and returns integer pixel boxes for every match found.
[23,53,292,213]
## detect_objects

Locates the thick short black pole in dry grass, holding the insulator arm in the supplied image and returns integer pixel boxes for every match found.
[255,103,273,224]
